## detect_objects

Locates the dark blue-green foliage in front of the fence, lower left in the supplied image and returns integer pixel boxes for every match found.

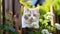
[0,19,18,34]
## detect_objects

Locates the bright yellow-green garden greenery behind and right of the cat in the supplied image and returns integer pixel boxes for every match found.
[20,0,60,34]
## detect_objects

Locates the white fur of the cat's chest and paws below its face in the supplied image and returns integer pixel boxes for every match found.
[22,17,39,28]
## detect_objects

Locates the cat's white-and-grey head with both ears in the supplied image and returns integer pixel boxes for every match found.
[23,7,39,22]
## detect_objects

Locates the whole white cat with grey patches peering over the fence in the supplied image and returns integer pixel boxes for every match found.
[22,7,39,28]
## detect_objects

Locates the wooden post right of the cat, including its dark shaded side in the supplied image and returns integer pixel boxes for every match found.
[50,5,60,34]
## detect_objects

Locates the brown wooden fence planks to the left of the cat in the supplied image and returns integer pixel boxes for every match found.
[3,0,22,34]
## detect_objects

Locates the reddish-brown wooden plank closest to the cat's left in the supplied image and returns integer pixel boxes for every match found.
[14,0,22,34]
